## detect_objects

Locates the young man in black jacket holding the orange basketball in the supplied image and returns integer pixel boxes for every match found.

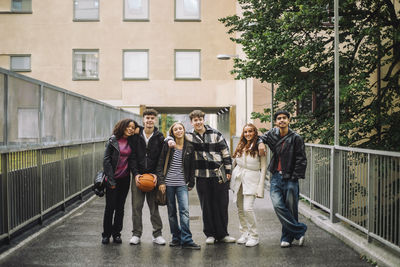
[130,109,165,245]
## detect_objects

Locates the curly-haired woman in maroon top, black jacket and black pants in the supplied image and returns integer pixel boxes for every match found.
[102,119,137,244]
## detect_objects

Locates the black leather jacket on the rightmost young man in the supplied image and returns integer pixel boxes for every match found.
[260,128,307,179]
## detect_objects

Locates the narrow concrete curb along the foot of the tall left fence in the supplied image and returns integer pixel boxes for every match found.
[0,195,98,261]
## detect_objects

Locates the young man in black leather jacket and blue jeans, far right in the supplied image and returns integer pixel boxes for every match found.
[259,110,307,248]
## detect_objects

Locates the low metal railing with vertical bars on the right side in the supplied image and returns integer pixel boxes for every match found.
[300,144,400,252]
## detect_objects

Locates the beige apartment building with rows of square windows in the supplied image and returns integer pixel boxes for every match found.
[0,0,271,141]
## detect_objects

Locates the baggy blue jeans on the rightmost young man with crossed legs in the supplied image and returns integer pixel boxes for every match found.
[270,173,307,243]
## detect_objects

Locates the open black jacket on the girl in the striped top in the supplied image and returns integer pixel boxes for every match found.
[157,140,195,188]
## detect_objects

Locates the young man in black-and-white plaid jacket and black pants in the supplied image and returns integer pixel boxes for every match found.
[167,110,236,244]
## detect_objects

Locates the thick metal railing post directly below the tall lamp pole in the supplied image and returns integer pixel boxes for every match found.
[329,147,340,223]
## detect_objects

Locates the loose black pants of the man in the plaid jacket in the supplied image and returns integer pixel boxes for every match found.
[196,178,229,240]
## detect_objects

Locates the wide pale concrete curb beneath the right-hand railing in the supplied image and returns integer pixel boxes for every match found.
[299,202,400,267]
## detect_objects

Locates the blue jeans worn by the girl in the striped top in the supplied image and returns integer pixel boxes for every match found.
[167,185,193,245]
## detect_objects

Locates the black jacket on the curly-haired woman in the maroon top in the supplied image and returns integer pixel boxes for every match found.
[103,135,135,186]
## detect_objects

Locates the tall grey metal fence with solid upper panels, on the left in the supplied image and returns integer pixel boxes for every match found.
[0,68,141,245]
